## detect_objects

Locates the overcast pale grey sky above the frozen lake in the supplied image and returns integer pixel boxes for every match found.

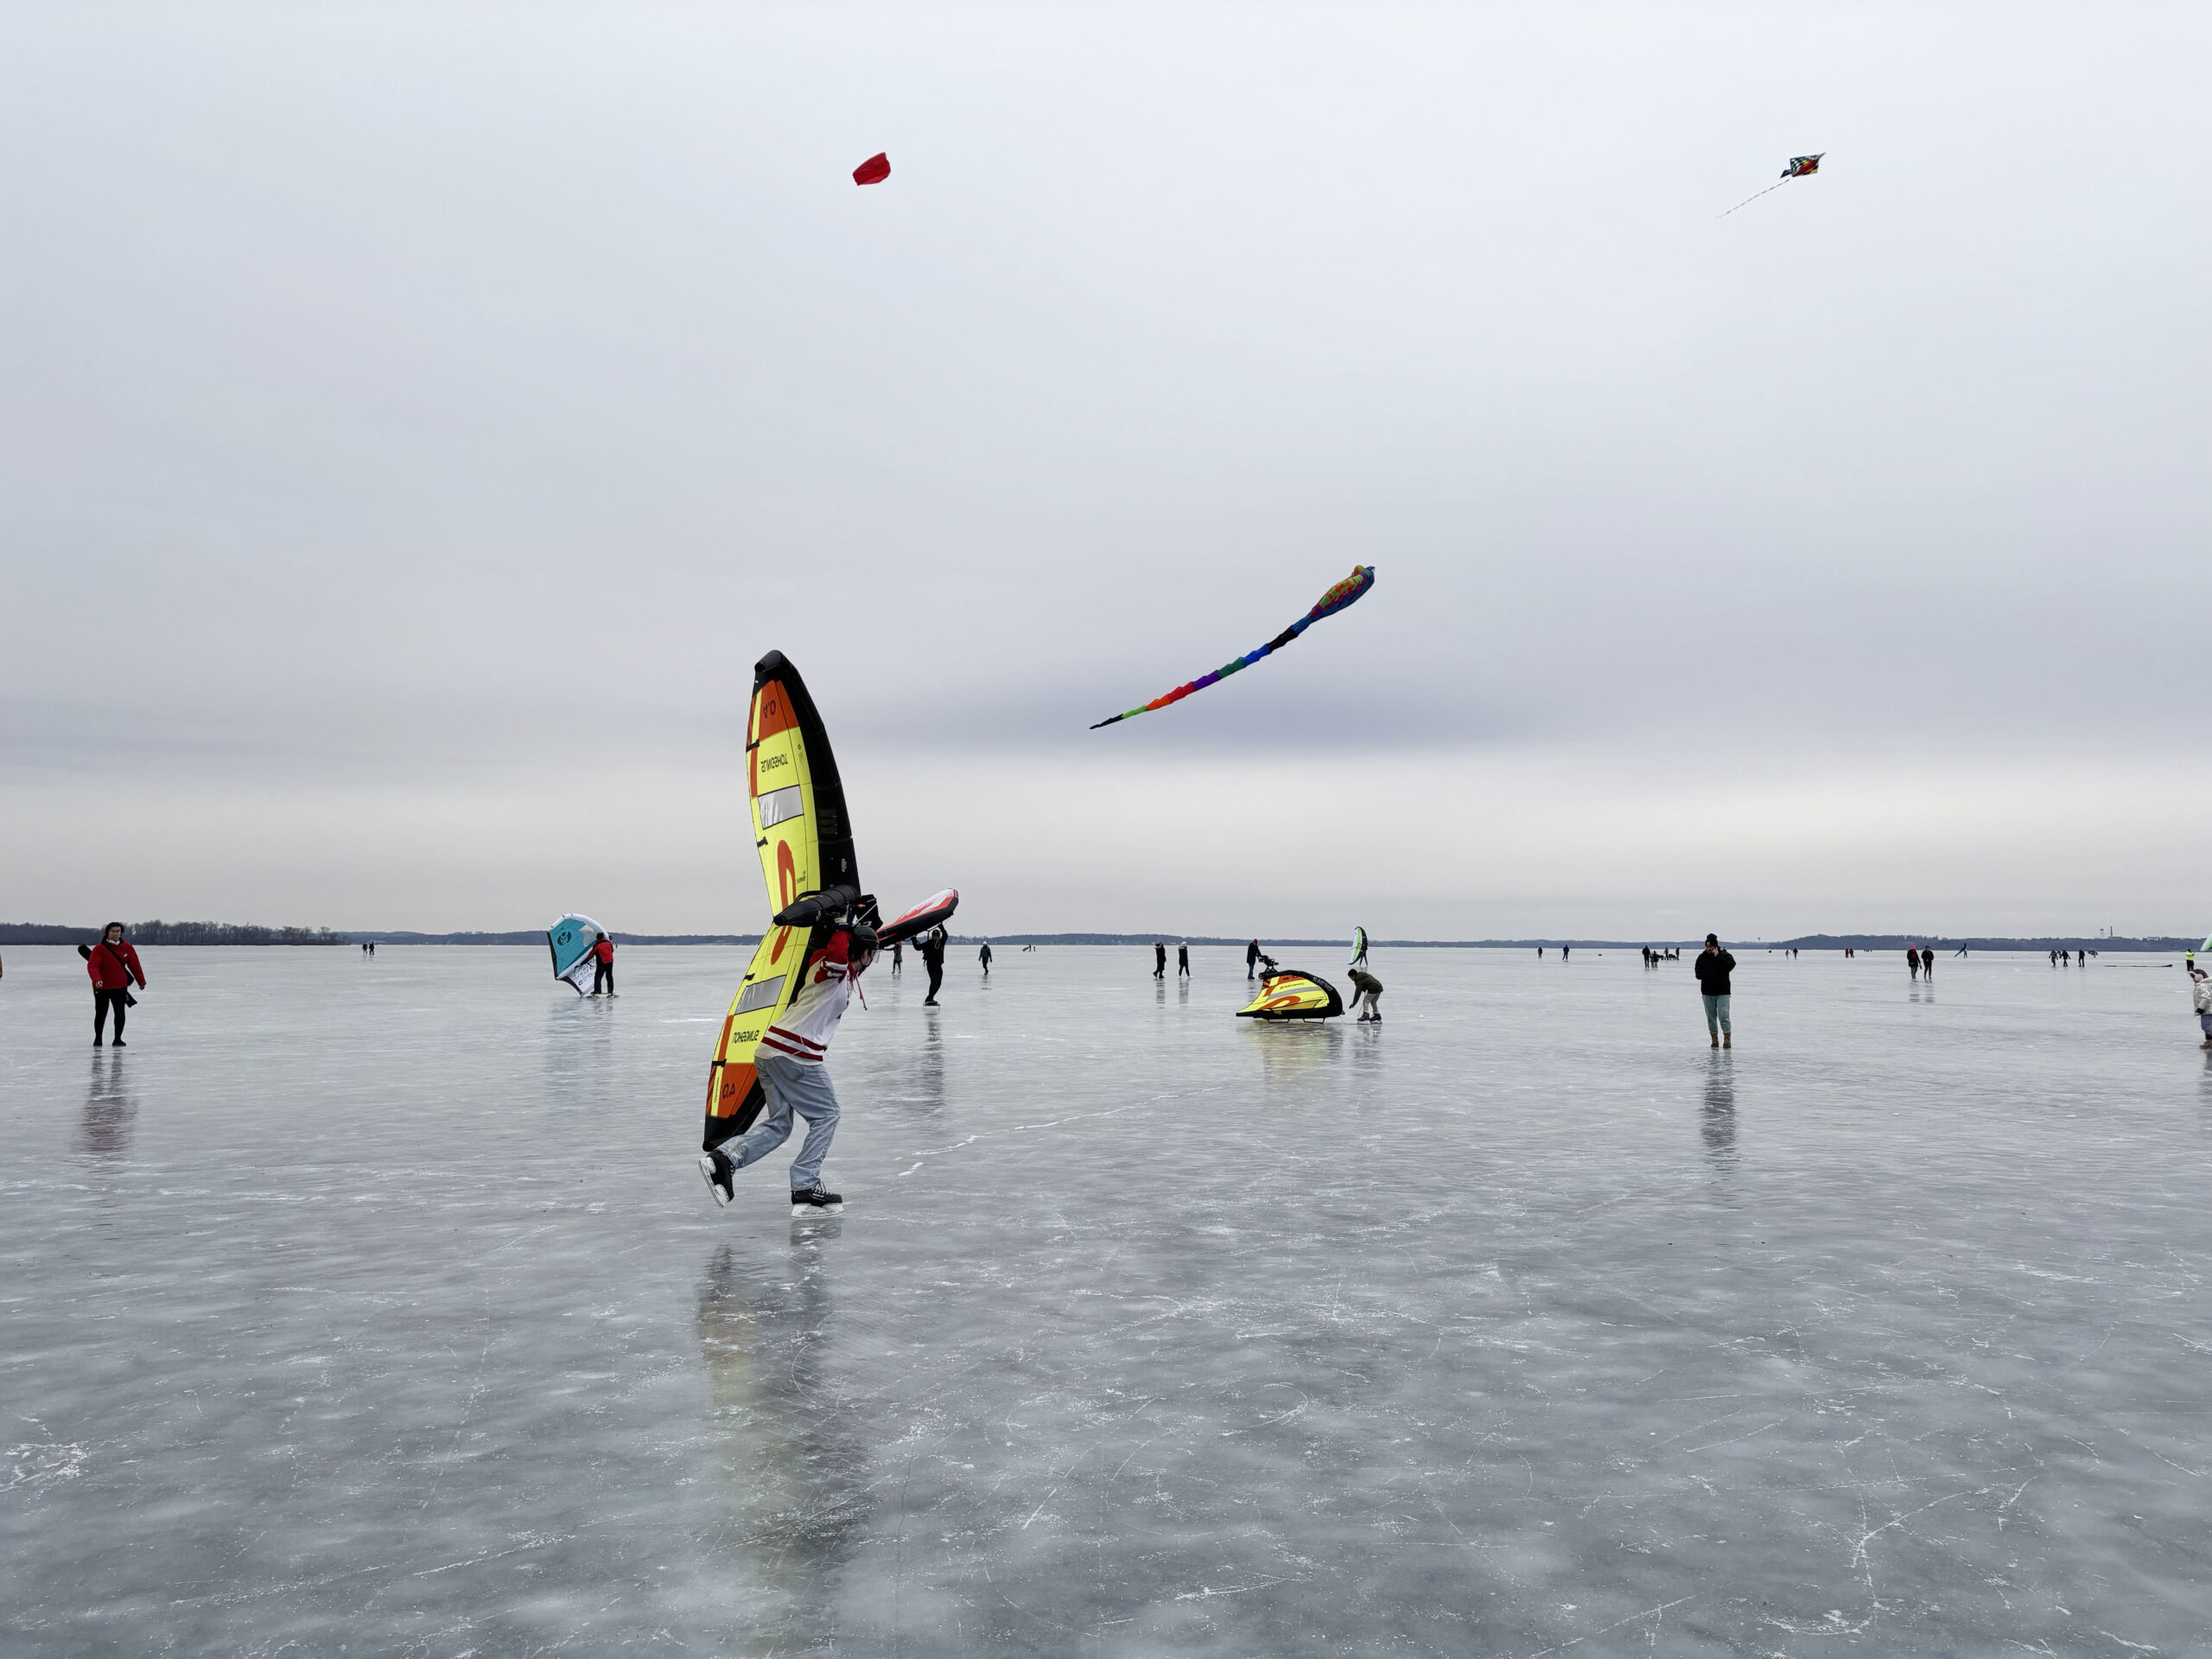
[0,0,2212,938]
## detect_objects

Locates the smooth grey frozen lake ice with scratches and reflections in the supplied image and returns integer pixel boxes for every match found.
[0,947,2212,1659]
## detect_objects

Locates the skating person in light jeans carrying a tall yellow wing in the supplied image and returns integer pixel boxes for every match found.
[699,923,876,1217]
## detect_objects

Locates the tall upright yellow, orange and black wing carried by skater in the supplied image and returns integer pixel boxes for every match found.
[702,651,861,1153]
